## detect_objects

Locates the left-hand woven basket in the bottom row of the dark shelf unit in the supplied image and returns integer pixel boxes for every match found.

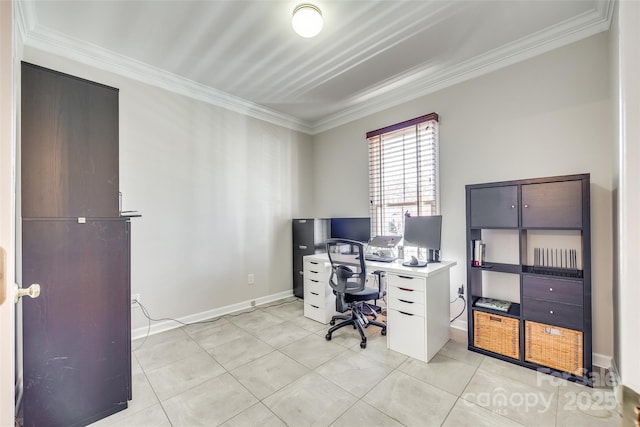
[473,310,520,359]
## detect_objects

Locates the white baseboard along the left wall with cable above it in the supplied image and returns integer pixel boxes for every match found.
[131,290,293,340]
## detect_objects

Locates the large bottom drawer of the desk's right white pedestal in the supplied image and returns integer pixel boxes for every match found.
[387,309,427,361]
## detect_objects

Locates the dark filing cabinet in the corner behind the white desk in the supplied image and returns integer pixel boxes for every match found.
[292,218,331,298]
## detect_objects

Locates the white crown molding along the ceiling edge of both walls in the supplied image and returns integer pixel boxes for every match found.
[16,0,615,135]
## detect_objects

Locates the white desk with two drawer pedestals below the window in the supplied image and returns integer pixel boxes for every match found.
[304,254,456,362]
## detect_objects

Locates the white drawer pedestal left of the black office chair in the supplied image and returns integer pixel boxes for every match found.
[304,259,336,324]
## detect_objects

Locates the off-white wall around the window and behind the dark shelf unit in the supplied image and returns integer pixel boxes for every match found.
[313,33,613,356]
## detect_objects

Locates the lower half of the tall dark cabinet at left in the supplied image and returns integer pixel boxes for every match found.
[22,220,131,427]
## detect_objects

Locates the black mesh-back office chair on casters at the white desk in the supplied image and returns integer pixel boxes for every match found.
[325,239,387,348]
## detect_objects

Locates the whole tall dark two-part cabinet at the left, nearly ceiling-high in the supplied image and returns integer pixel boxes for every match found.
[20,63,131,426]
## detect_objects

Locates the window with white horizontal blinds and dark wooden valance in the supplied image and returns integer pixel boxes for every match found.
[367,113,439,236]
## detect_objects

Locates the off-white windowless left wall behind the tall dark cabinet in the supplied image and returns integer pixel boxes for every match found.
[24,48,313,329]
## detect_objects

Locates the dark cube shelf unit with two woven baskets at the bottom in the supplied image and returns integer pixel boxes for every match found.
[466,174,592,385]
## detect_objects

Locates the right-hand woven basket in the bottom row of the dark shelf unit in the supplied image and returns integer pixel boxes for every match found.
[525,320,584,376]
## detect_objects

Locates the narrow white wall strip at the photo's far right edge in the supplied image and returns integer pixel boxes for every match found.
[611,1,640,394]
